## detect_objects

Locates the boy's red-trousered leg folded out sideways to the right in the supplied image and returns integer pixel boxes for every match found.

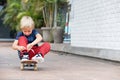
[29,42,50,59]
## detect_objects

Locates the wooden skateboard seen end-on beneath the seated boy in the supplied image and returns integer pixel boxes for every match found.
[20,60,38,71]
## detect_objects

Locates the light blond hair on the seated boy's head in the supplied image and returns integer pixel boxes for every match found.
[20,16,34,29]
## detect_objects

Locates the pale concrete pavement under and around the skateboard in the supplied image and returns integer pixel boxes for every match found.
[0,43,120,80]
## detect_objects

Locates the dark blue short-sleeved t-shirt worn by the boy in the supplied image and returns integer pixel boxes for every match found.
[16,29,38,43]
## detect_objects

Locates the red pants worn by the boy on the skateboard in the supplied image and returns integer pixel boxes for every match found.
[18,36,50,59]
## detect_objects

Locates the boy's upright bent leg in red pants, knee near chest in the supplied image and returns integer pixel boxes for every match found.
[18,36,28,56]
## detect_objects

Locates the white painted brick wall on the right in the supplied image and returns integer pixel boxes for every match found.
[70,0,120,50]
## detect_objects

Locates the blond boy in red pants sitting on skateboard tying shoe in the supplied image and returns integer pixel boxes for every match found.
[12,16,50,62]
